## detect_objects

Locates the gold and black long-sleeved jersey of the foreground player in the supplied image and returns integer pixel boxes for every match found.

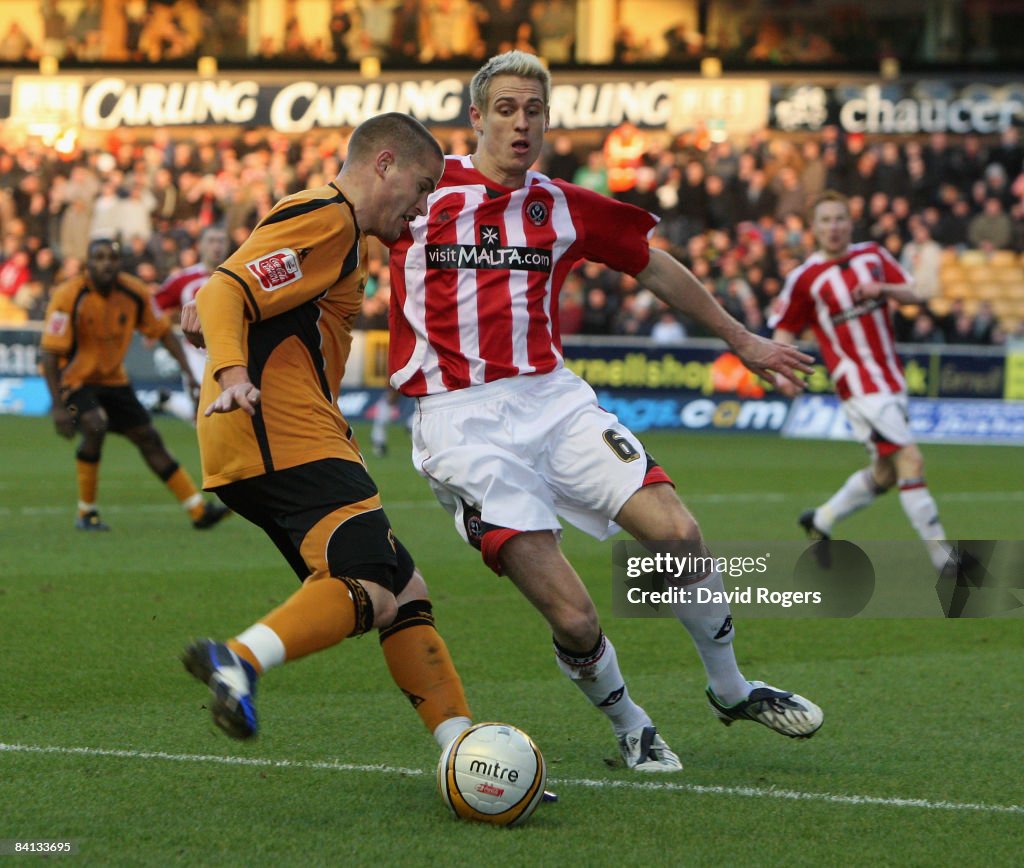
[197,184,367,488]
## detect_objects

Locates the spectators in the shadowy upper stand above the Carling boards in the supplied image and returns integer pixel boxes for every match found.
[0,0,1003,69]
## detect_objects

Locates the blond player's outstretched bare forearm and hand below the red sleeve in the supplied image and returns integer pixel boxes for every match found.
[637,248,814,389]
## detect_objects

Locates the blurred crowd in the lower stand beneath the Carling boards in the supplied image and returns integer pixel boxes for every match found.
[0,124,1024,344]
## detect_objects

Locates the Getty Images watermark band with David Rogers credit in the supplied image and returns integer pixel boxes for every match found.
[612,539,1024,618]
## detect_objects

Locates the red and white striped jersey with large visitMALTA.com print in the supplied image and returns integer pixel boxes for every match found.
[388,157,657,397]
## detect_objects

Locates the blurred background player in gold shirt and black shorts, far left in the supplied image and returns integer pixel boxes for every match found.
[41,238,228,530]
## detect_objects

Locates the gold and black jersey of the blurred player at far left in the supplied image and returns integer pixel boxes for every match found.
[40,273,171,391]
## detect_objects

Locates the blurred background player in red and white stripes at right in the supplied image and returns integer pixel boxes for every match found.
[771,190,948,571]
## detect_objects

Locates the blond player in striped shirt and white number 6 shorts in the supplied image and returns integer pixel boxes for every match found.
[390,51,822,772]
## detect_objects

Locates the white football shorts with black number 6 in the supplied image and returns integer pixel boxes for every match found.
[413,368,659,541]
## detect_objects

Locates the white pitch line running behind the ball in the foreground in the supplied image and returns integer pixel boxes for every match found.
[0,742,1024,816]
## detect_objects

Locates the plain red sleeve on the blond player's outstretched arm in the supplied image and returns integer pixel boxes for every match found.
[555,181,658,276]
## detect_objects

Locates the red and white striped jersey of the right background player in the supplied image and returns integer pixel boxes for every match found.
[769,242,911,400]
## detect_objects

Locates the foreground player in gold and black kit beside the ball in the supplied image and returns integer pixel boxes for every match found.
[182,113,470,747]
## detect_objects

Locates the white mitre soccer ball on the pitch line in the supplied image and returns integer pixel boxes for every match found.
[437,724,548,826]
